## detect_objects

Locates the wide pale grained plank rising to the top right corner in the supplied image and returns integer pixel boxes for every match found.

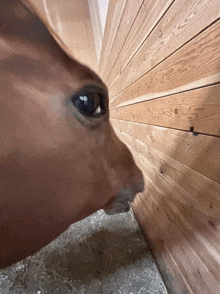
[107,0,220,97]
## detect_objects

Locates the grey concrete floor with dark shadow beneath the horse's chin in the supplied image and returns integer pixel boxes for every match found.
[0,210,167,294]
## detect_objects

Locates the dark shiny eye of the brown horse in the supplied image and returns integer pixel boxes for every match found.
[71,91,106,118]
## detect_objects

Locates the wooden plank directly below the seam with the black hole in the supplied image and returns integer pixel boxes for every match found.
[111,119,220,183]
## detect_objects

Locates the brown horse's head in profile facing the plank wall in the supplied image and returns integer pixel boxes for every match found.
[0,0,143,266]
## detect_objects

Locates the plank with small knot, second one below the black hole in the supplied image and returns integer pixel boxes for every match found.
[115,130,220,219]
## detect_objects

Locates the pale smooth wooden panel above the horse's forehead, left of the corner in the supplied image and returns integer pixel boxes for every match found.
[25,0,98,71]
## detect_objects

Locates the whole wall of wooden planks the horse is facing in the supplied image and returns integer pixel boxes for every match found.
[99,0,220,294]
